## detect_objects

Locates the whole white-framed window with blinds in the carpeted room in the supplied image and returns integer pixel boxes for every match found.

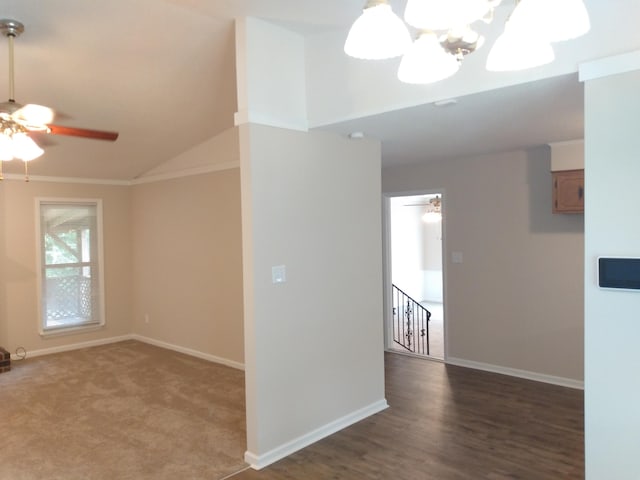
[37,199,104,334]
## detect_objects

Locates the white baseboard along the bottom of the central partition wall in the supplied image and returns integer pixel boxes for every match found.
[244,399,389,470]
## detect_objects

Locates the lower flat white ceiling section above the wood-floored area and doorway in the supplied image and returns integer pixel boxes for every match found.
[327,74,584,167]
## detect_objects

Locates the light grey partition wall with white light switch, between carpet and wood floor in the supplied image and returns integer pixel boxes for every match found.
[240,125,386,467]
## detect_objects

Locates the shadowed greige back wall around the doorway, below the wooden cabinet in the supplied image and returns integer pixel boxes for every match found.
[382,147,584,383]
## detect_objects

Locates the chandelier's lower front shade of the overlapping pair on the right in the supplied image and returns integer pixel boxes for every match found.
[487,19,555,72]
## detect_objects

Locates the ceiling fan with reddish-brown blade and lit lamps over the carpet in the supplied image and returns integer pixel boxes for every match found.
[0,19,118,181]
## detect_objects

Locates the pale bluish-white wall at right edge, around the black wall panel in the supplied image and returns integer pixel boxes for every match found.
[585,59,640,480]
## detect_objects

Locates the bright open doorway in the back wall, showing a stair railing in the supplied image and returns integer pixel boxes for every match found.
[385,191,445,360]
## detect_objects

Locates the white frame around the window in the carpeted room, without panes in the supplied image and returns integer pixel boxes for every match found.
[35,197,106,336]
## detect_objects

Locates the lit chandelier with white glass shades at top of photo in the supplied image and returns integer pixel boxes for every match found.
[344,0,590,84]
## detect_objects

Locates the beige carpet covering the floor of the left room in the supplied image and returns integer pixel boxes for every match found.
[0,341,246,480]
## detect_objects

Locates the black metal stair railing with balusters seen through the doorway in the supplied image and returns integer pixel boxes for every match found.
[391,285,431,355]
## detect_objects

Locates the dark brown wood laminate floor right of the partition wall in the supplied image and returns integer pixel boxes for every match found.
[231,353,584,480]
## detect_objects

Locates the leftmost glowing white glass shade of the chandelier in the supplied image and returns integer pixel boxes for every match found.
[344,2,411,60]
